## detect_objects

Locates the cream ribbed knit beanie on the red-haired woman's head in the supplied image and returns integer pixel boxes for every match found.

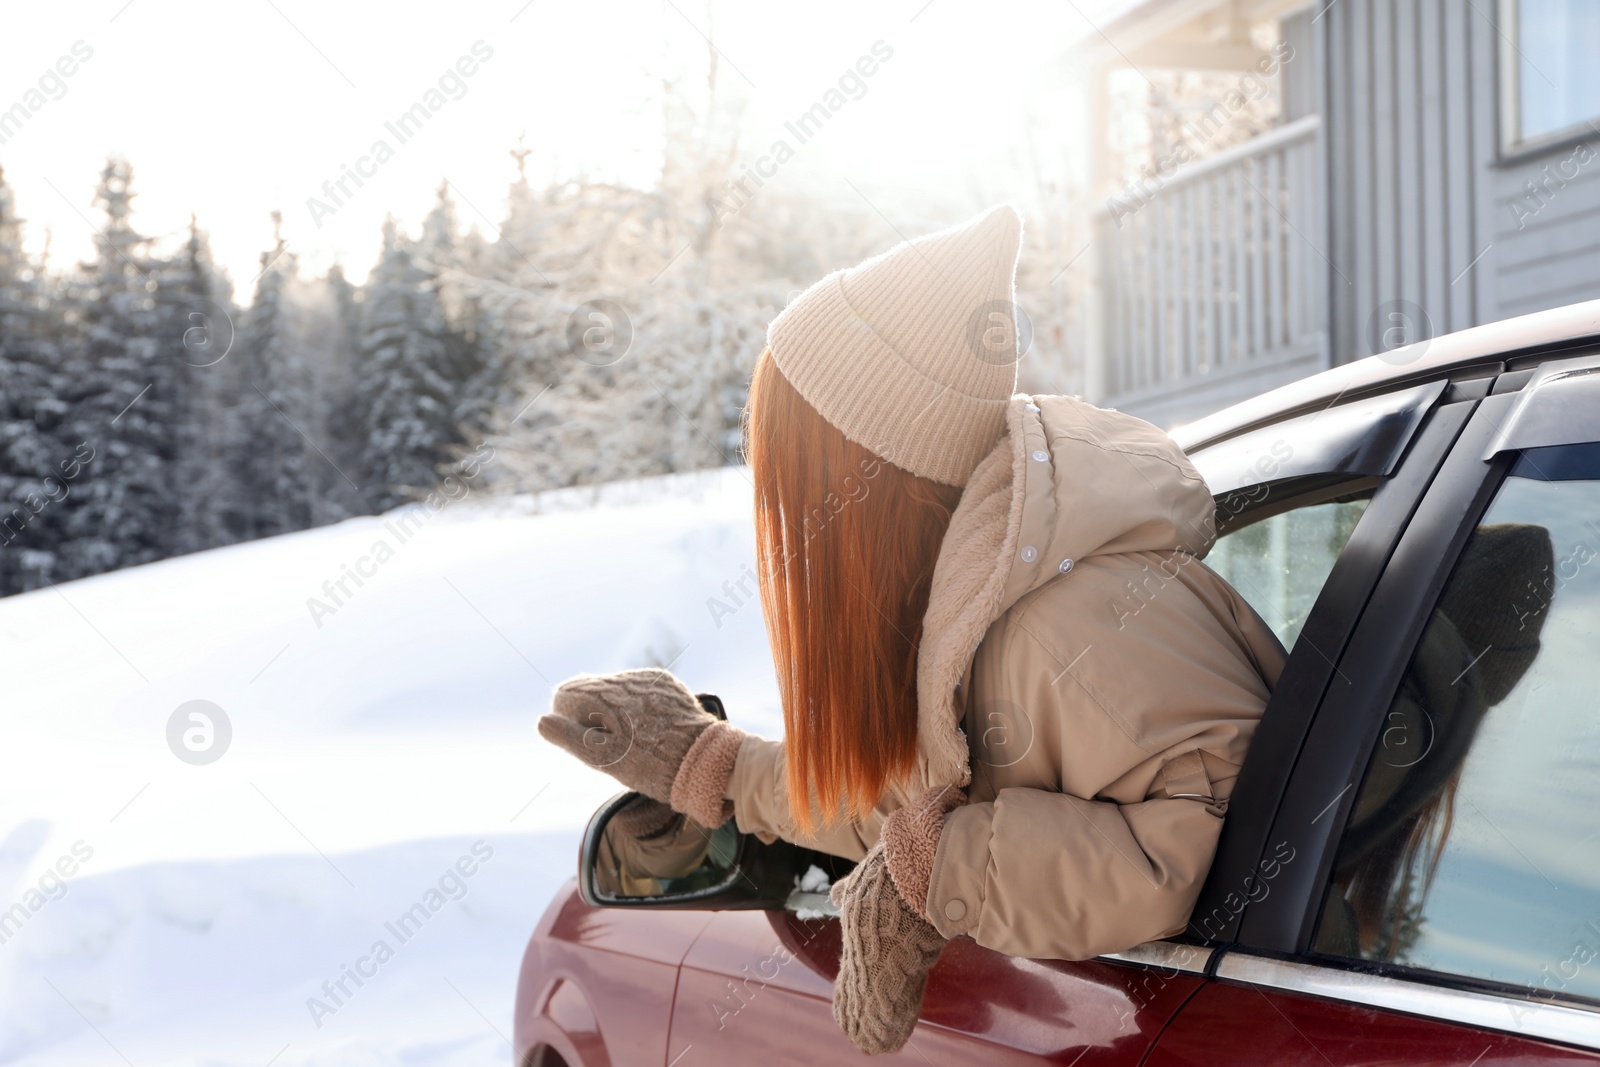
[766,205,1022,486]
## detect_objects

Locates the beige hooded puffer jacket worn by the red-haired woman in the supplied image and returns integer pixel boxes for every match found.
[728,395,1283,960]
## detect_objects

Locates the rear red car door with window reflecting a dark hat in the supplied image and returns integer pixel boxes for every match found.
[1149,357,1600,1067]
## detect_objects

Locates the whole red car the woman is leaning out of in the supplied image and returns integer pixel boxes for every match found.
[515,301,1600,1067]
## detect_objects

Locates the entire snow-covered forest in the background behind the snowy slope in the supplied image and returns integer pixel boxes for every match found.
[0,115,1064,595]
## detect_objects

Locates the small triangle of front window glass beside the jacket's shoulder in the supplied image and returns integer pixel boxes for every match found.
[1205,499,1366,648]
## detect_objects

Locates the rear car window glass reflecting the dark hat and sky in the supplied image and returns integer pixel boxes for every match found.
[1315,445,1600,998]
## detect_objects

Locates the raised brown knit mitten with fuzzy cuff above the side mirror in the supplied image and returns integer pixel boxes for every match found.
[539,667,744,827]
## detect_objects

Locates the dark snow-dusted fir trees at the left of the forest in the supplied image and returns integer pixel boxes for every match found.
[0,160,509,593]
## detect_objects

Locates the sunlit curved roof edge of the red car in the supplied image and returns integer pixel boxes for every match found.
[1173,299,1600,451]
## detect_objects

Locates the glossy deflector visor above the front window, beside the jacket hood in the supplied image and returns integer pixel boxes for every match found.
[1190,379,1448,496]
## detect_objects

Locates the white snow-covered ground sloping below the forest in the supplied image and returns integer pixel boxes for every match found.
[0,469,781,1067]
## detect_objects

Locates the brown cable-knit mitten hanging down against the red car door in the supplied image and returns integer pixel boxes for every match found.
[832,843,946,1056]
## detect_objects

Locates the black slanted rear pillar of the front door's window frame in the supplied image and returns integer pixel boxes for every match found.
[1184,391,1478,944]
